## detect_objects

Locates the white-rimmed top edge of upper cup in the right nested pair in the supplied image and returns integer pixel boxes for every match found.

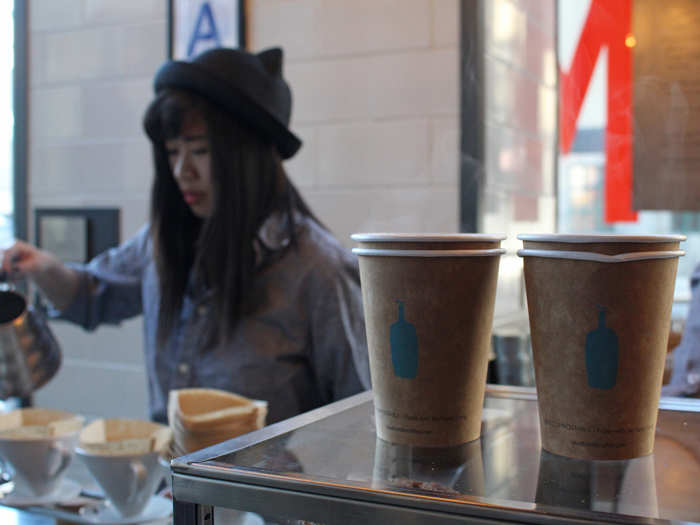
[518,233,686,255]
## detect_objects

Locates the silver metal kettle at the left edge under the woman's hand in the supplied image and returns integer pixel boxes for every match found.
[0,271,61,399]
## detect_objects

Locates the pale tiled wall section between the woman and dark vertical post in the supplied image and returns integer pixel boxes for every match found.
[258,0,459,246]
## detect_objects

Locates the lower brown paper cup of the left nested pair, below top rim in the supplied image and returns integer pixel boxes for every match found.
[353,248,505,447]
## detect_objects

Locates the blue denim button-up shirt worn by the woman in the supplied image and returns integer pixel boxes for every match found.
[58,216,370,423]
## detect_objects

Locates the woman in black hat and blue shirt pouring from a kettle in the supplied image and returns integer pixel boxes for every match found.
[3,49,369,423]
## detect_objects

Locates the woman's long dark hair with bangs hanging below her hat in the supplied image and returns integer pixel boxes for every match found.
[144,90,313,346]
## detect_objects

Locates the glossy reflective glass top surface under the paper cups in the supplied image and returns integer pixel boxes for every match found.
[173,387,700,523]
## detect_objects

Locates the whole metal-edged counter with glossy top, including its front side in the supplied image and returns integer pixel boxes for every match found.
[171,386,700,525]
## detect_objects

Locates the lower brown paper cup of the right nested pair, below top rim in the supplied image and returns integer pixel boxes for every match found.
[518,249,684,459]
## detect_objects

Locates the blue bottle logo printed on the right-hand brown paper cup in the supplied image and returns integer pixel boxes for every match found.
[586,306,618,390]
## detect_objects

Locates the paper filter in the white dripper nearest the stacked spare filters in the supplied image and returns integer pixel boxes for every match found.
[80,419,172,455]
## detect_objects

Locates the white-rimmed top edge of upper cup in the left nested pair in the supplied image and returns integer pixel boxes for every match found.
[350,233,506,250]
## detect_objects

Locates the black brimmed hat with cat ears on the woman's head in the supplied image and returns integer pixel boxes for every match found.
[153,47,301,159]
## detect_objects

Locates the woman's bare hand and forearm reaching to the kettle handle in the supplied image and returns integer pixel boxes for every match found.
[2,241,80,310]
